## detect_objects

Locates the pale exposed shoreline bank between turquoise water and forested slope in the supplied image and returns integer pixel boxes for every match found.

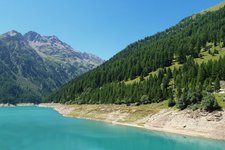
[38,103,225,140]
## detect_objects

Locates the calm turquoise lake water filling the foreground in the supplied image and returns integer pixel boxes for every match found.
[0,107,225,150]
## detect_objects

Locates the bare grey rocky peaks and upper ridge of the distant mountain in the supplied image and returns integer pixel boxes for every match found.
[2,30,104,66]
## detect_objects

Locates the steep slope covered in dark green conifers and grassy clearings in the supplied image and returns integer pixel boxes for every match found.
[47,3,225,110]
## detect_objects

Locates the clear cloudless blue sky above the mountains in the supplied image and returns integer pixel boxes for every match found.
[0,0,223,60]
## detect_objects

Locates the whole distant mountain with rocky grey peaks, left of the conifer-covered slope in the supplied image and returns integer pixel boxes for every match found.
[0,30,103,103]
